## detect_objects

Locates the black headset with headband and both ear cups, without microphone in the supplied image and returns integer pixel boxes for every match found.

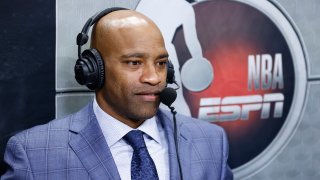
[74,7,177,90]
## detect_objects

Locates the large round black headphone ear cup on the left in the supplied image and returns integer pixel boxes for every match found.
[74,49,104,90]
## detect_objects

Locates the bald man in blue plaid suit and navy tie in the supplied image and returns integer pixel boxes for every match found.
[1,10,232,180]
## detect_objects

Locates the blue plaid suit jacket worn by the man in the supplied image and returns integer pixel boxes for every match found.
[1,103,233,180]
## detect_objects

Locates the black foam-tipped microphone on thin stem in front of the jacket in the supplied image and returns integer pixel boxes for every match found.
[160,87,183,180]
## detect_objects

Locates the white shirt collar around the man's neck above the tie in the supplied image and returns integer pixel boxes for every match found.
[93,98,161,148]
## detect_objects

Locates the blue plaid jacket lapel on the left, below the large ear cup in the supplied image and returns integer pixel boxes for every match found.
[69,103,120,180]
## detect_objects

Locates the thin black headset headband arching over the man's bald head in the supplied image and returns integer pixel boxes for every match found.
[77,7,128,58]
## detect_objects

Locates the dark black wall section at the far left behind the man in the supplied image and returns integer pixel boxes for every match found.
[0,0,55,174]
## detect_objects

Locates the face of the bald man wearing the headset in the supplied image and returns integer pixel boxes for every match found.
[97,17,168,123]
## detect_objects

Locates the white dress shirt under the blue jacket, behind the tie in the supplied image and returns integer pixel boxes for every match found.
[93,99,170,180]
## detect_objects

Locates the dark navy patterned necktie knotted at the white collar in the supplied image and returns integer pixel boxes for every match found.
[123,130,159,180]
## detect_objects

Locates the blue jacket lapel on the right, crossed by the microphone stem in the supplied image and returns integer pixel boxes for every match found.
[157,110,191,179]
